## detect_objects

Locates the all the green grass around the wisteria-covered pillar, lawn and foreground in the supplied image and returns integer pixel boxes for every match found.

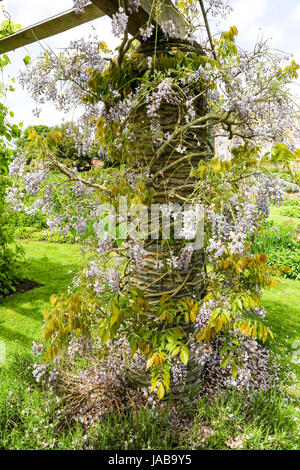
[0,241,300,450]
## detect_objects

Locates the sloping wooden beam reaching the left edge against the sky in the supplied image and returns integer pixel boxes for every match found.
[0,3,105,54]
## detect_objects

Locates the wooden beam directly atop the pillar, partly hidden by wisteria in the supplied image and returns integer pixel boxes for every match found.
[91,0,187,39]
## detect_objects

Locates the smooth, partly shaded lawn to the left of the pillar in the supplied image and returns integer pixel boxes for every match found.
[0,241,80,358]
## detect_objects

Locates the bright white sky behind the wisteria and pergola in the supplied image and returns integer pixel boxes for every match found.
[0,0,300,127]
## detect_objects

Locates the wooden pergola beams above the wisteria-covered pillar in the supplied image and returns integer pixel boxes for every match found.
[0,0,187,54]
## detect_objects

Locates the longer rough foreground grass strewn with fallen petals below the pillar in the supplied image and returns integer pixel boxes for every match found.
[0,354,299,450]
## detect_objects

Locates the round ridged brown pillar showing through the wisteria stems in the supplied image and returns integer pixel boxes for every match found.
[123,39,211,392]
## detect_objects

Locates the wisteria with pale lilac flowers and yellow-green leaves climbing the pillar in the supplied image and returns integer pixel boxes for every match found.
[9,0,299,399]
